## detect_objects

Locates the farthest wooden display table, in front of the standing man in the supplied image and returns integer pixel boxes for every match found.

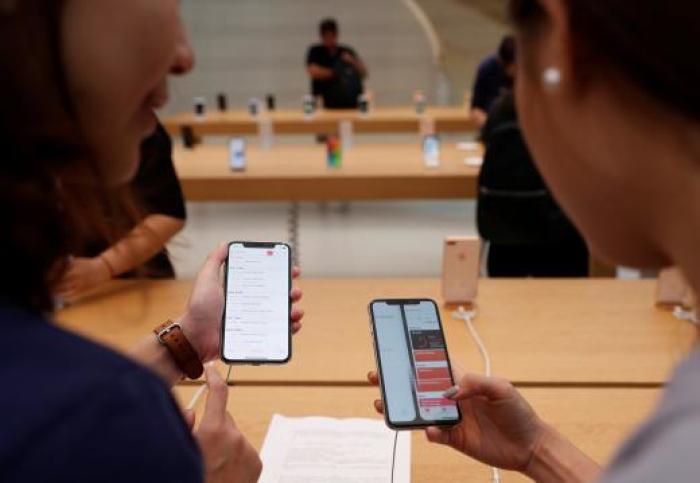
[163,107,478,136]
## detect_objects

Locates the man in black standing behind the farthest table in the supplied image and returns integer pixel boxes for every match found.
[306,18,367,109]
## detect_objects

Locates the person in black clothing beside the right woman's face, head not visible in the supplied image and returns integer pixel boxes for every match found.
[477,89,589,277]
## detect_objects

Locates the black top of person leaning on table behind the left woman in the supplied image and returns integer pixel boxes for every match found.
[81,124,187,278]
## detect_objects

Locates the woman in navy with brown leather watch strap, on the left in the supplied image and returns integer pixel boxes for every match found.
[0,0,302,483]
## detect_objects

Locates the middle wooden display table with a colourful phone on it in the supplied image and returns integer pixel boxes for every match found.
[173,144,482,201]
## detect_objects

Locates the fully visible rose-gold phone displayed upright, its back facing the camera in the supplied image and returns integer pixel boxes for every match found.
[442,236,481,304]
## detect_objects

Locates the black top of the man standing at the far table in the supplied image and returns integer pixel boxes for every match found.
[306,44,363,109]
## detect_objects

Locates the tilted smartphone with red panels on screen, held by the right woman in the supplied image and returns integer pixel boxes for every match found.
[369,299,462,430]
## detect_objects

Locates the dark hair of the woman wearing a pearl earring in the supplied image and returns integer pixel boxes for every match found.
[510,0,700,118]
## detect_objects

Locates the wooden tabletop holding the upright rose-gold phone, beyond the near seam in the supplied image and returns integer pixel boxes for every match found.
[58,279,697,387]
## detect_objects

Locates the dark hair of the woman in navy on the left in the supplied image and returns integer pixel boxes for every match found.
[0,0,132,311]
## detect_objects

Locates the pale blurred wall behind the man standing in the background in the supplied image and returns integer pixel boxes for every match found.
[164,0,506,113]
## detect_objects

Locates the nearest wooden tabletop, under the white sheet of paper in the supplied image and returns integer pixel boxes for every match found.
[175,386,659,483]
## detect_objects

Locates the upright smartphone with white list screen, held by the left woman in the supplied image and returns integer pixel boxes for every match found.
[221,242,292,365]
